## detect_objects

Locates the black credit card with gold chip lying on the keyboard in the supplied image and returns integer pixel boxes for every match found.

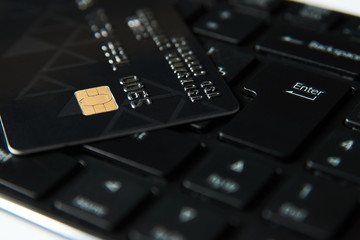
[0,0,239,154]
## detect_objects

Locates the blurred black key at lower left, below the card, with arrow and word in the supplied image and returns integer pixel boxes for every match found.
[54,166,150,230]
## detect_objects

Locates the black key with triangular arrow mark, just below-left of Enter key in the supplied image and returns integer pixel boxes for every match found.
[183,148,274,208]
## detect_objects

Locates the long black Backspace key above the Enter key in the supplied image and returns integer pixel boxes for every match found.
[255,26,360,78]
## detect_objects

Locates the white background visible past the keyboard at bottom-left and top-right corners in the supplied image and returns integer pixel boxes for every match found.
[0,0,360,240]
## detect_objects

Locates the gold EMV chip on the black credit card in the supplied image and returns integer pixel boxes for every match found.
[75,86,119,116]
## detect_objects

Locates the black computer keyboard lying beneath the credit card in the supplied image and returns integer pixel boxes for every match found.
[0,0,360,240]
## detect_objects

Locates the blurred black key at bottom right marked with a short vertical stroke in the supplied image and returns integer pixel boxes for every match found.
[263,176,356,240]
